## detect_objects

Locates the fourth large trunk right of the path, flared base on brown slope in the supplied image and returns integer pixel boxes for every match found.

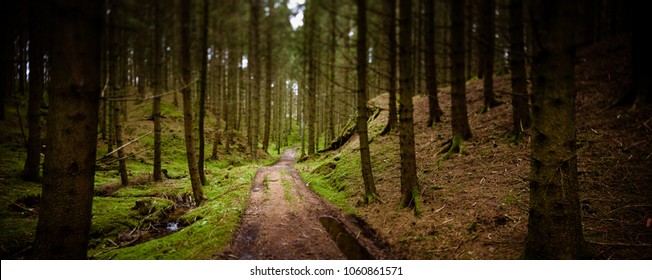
[425,1,444,127]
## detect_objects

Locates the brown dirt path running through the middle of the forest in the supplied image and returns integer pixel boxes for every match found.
[227,148,380,260]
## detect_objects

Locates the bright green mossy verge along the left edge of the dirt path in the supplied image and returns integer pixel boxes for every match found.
[89,165,260,259]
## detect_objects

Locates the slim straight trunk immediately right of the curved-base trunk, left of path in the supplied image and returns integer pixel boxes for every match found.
[197,0,210,186]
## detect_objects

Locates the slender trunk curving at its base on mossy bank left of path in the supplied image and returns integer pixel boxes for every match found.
[181,1,204,205]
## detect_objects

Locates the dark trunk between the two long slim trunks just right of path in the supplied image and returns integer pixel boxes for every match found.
[384,0,398,133]
